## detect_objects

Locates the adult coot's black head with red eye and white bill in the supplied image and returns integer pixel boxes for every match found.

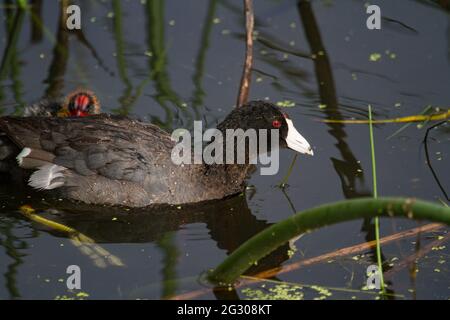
[218,101,314,155]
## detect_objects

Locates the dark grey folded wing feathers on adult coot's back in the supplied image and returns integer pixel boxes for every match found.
[0,115,175,183]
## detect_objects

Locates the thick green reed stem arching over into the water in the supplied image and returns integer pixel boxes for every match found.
[208,197,450,284]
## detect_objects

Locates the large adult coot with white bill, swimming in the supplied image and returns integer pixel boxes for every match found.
[0,101,312,207]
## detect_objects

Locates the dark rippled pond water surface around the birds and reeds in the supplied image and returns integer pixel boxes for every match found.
[0,0,450,299]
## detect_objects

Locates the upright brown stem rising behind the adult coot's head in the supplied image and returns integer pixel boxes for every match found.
[237,0,255,107]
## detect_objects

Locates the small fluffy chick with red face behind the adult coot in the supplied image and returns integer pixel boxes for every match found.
[24,89,100,117]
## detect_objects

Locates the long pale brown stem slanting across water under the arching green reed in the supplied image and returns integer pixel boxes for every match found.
[170,223,444,300]
